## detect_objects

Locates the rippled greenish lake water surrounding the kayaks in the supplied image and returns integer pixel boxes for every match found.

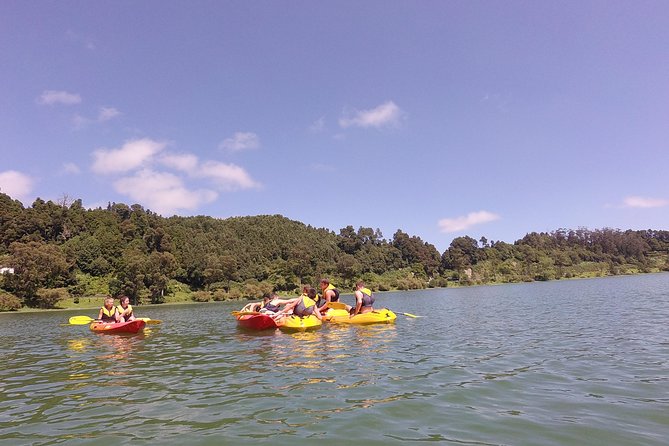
[0,274,669,445]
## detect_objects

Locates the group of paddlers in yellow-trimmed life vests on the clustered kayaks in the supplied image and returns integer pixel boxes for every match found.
[242,279,374,319]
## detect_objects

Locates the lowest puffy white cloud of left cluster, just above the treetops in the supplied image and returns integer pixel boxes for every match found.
[114,169,218,215]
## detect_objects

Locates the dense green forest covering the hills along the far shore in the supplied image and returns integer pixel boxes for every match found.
[0,193,669,310]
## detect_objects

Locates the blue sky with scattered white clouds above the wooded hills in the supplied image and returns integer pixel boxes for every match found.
[0,0,669,252]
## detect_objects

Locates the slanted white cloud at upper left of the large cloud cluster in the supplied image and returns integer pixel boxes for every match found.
[92,138,167,174]
